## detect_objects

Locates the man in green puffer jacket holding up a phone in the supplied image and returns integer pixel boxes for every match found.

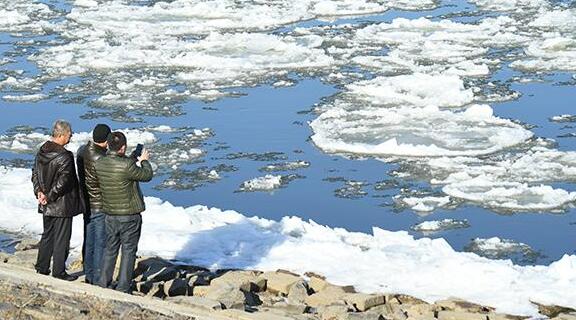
[95,132,153,293]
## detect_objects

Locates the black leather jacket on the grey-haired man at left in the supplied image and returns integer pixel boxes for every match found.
[32,141,84,218]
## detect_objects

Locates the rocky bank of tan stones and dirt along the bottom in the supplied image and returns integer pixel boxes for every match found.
[0,239,576,320]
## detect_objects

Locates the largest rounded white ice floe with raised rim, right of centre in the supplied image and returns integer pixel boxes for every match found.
[310,101,532,157]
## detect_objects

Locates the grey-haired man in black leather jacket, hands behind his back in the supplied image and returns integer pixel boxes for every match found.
[32,120,83,281]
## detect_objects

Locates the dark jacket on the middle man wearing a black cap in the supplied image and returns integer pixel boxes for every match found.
[76,141,106,211]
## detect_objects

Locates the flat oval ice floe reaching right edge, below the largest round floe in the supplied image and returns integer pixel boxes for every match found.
[442,177,576,211]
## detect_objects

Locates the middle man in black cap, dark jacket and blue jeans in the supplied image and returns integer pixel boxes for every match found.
[76,124,110,284]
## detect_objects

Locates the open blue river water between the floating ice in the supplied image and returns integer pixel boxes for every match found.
[0,1,576,264]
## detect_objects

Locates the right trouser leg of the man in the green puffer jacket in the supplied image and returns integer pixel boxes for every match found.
[116,214,142,293]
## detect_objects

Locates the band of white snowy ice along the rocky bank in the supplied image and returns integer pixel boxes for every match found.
[0,167,576,316]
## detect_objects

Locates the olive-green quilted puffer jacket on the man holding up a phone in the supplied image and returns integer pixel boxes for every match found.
[95,151,153,215]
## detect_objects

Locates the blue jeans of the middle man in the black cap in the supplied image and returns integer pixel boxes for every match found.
[83,209,106,284]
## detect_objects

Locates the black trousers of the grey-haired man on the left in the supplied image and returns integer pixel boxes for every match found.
[36,216,72,277]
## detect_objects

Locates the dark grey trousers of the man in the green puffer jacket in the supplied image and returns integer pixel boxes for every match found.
[100,214,142,293]
